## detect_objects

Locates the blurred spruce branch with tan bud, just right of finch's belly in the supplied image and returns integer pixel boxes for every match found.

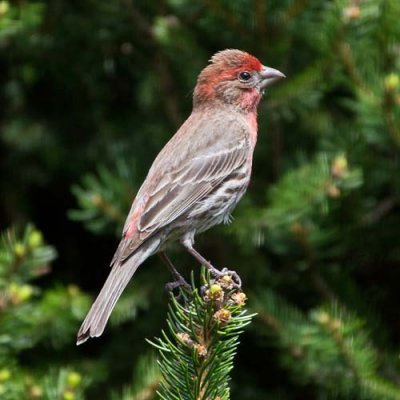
[231,153,363,250]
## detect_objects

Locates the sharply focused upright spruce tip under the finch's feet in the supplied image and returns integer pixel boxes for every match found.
[150,271,254,400]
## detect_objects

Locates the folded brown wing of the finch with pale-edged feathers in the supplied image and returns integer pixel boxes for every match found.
[111,139,249,265]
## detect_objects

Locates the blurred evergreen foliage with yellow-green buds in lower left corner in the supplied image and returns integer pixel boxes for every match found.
[0,225,88,400]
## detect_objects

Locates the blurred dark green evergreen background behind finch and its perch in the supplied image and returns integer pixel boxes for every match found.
[0,0,400,400]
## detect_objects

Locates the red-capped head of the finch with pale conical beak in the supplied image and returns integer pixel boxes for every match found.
[193,49,285,111]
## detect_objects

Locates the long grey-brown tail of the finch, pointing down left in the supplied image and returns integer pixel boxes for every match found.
[76,242,153,345]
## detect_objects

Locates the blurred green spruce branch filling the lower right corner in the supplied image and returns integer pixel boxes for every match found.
[252,290,400,400]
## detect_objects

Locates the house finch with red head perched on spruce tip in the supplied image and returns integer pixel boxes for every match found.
[77,50,284,344]
